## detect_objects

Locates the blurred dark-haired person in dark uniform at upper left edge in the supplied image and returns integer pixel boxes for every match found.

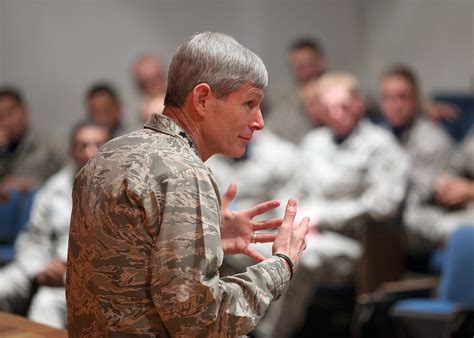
[0,87,64,194]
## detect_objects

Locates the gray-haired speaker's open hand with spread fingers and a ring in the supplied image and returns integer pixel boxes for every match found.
[221,183,282,262]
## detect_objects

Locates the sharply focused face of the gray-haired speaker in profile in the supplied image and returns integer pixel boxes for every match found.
[203,85,264,157]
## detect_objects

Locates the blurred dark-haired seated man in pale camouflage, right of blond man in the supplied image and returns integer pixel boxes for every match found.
[380,66,466,255]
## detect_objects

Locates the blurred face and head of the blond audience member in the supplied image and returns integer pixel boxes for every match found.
[320,87,363,137]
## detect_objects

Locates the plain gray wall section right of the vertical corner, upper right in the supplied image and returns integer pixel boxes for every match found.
[362,0,474,94]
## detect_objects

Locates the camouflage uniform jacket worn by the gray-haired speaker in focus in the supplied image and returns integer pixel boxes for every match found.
[66,114,290,337]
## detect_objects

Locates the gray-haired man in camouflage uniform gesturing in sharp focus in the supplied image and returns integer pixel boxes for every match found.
[67,32,309,337]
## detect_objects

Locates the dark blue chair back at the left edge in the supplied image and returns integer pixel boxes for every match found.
[0,190,36,266]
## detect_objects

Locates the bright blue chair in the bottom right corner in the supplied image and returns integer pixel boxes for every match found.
[390,226,474,338]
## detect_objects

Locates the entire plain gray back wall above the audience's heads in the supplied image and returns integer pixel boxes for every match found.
[0,0,474,139]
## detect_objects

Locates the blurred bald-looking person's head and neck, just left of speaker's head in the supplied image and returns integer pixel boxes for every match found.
[132,54,166,123]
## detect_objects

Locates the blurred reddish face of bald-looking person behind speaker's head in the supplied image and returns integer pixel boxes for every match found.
[134,57,166,97]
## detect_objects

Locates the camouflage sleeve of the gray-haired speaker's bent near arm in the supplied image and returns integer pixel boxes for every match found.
[151,169,289,337]
